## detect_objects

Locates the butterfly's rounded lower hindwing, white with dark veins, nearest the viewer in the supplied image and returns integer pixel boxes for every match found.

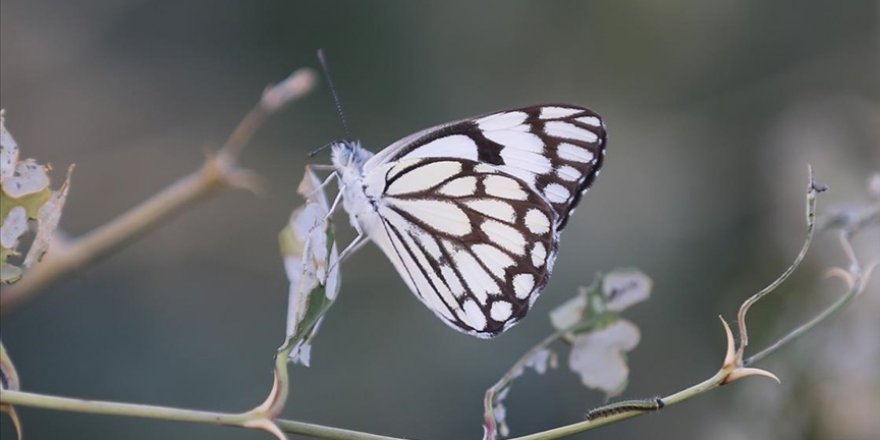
[365,158,558,337]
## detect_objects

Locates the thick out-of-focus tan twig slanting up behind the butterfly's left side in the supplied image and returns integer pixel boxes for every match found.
[0,69,315,313]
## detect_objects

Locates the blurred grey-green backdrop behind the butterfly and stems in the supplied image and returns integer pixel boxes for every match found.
[0,0,880,439]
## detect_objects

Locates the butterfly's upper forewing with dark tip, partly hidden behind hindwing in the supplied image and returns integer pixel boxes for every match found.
[364,104,606,230]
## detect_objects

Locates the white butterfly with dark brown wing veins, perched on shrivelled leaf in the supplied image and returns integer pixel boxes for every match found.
[330,104,606,338]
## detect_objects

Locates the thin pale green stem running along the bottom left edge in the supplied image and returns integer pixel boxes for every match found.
[0,390,399,440]
